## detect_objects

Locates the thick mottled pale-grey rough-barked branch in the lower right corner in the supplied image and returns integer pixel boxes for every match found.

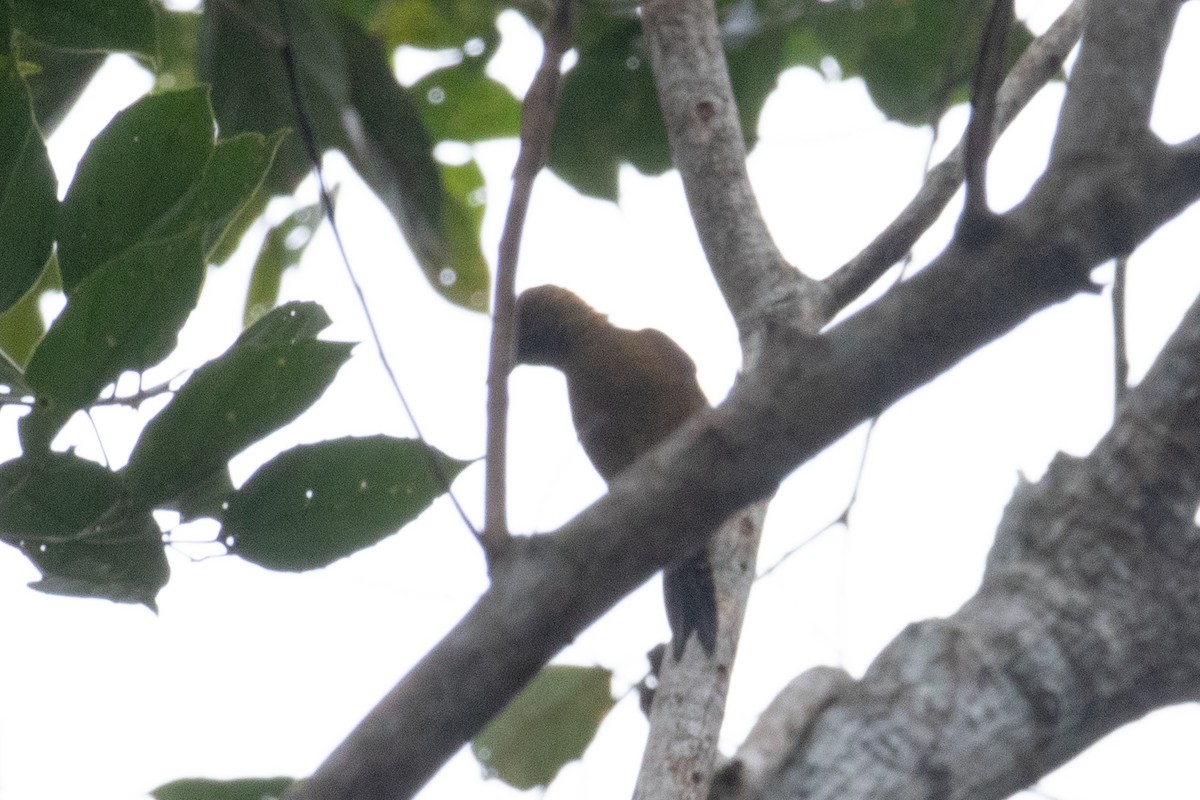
[755,275,1200,800]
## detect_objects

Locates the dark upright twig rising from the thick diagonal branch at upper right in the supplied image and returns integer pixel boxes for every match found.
[962,0,1013,223]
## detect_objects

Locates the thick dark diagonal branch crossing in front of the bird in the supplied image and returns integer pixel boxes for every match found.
[278,128,1200,800]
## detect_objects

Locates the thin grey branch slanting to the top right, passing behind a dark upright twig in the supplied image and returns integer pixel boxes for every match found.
[824,0,1090,314]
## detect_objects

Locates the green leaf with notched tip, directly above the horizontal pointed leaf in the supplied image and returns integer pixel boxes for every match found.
[124,303,353,506]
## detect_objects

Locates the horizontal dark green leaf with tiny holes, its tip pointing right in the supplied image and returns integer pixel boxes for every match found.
[222,435,469,571]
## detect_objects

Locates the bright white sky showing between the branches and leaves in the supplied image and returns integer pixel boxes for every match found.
[0,1,1200,800]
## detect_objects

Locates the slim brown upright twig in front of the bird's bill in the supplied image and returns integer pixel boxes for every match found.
[482,0,574,553]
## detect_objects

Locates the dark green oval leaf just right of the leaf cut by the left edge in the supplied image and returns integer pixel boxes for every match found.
[59,88,214,294]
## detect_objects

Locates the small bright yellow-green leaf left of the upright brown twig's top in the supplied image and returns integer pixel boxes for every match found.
[409,61,521,142]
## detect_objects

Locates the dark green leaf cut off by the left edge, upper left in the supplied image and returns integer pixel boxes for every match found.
[0,55,59,311]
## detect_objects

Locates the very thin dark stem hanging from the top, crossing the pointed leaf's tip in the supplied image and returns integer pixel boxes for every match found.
[276,0,480,539]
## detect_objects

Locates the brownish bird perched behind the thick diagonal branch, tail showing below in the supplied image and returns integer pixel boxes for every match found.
[516,284,716,661]
